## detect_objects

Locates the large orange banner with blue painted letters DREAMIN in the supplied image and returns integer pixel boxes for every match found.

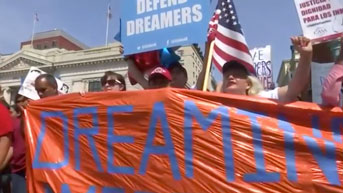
[25,89,343,193]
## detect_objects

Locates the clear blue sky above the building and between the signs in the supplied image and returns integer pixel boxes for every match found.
[0,0,302,81]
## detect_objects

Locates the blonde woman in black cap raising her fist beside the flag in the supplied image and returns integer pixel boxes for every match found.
[222,37,312,102]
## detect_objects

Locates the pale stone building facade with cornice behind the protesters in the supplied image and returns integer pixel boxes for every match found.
[0,30,202,104]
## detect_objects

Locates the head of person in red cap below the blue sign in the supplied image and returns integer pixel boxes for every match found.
[148,67,172,89]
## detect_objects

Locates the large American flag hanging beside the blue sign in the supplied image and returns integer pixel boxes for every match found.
[208,0,255,74]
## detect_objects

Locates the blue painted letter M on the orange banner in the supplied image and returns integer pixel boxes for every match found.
[184,101,235,181]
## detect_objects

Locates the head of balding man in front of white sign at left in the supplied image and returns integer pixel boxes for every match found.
[35,74,58,99]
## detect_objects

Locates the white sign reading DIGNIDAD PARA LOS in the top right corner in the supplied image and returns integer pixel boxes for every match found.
[294,0,343,41]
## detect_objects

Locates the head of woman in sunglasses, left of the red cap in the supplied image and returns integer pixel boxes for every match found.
[100,71,126,91]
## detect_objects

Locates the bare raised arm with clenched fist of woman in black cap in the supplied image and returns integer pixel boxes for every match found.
[278,36,313,102]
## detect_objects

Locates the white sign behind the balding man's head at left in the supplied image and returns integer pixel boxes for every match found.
[18,67,69,100]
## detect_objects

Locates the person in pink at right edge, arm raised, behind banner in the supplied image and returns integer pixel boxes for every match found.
[321,36,343,106]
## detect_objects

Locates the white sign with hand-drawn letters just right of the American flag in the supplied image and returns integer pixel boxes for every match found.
[250,45,273,89]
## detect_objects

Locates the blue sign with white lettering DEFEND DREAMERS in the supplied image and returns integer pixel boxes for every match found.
[121,0,210,55]
